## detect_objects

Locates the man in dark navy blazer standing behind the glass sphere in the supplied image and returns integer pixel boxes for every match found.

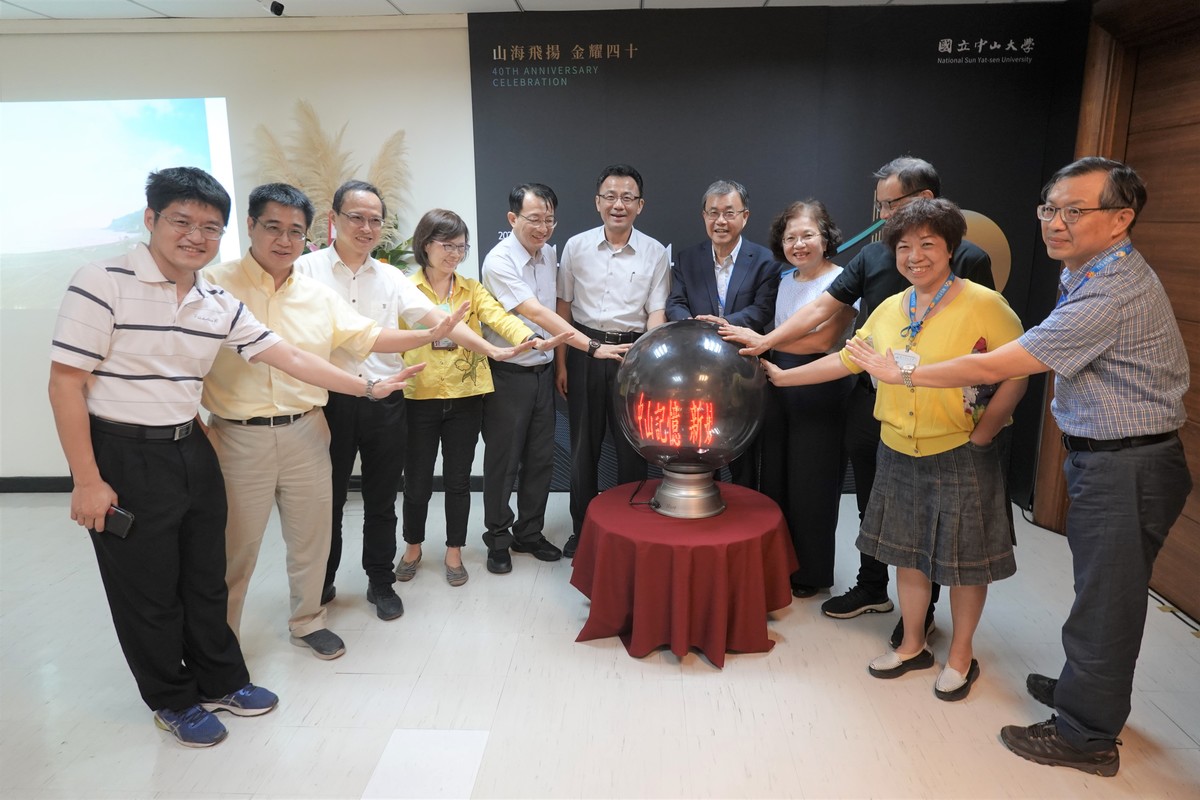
[666,180,782,488]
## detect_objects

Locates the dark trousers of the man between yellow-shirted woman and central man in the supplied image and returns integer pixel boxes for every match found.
[484,360,554,549]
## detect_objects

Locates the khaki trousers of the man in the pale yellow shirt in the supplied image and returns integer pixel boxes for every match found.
[210,411,332,637]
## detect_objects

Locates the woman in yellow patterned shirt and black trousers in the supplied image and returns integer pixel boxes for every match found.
[396,209,563,587]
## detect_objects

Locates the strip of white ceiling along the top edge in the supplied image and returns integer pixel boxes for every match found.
[0,0,1060,20]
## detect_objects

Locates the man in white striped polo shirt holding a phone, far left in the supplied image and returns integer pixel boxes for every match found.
[49,168,417,747]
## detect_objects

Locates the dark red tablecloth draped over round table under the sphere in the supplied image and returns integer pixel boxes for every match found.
[571,481,798,667]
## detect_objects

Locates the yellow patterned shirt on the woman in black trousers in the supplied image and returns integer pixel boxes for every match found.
[400,269,533,399]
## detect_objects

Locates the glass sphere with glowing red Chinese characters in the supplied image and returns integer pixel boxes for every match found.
[617,319,767,469]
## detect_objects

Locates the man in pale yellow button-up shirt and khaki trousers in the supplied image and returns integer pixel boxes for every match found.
[202,184,522,658]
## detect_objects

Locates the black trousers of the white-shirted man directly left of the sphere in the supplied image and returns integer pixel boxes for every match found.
[566,348,647,534]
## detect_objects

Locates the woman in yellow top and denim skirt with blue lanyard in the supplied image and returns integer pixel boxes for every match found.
[764,199,1026,700]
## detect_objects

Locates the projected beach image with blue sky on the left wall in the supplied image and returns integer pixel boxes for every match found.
[0,97,239,309]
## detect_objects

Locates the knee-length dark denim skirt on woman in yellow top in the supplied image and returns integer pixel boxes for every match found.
[856,441,1016,587]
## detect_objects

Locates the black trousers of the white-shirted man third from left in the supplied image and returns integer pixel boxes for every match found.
[325,392,406,589]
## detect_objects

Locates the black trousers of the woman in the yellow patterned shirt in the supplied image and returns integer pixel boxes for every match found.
[404,395,484,547]
